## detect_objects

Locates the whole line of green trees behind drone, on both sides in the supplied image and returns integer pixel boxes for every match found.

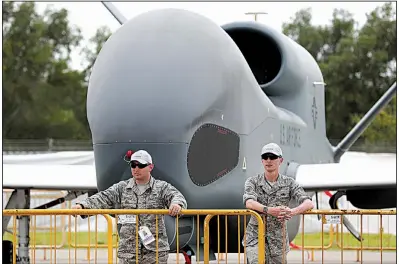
[2,2,396,151]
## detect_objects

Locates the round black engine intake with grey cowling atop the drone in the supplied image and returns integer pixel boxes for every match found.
[222,22,321,96]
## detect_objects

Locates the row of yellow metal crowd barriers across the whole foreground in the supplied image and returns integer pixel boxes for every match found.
[3,209,396,263]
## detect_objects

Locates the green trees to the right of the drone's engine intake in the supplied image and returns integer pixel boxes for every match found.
[283,3,396,148]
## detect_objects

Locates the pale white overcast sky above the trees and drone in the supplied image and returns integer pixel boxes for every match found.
[36,2,394,69]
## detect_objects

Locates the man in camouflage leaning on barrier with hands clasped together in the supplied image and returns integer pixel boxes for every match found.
[242,143,313,264]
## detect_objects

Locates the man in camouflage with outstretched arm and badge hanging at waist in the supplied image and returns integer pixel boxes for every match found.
[74,150,187,264]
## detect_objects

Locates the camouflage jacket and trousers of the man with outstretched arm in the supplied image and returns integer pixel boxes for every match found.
[79,176,187,259]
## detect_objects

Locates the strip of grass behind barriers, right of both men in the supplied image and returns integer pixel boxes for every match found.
[293,232,396,250]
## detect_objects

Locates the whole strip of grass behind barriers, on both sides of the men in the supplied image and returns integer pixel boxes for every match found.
[3,231,396,250]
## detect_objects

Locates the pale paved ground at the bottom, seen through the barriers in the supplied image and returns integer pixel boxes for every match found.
[16,249,396,264]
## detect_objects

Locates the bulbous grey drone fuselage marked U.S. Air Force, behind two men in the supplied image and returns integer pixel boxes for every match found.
[87,9,334,252]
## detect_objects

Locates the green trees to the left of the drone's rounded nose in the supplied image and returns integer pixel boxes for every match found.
[2,2,89,138]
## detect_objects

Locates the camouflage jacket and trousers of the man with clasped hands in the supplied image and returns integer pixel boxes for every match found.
[243,173,311,257]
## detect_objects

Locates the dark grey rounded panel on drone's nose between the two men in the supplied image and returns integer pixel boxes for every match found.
[187,124,240,186]
